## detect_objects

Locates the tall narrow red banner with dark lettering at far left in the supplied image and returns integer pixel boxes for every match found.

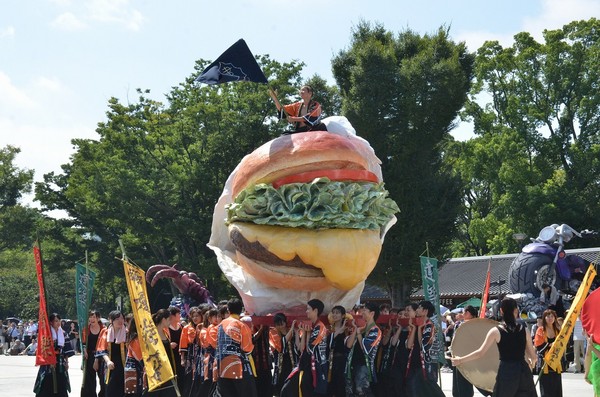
[33,245,56,365]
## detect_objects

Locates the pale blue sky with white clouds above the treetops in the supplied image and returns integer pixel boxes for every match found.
[0,0,600,207]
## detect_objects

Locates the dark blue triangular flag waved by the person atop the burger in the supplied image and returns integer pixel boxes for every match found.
[196,39,267,84]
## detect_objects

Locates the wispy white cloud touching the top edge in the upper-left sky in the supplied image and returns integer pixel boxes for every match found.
[87,0,145,31]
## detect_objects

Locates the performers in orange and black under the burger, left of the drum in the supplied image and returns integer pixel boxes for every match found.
[27,299,446,397]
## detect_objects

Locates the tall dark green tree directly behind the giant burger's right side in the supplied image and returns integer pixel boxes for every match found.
[333,22,474,305]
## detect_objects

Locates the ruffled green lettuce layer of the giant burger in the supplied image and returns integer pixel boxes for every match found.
[226,178,400,230]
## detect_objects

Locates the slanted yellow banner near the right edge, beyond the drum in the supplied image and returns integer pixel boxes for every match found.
[544,263,596,371]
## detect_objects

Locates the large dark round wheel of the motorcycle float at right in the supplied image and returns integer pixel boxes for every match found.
[508,252,556,297]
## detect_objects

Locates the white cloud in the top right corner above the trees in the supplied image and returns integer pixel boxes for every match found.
[522,0,600,41]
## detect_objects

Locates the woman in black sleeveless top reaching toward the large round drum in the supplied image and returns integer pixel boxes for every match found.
[452,298,537,397]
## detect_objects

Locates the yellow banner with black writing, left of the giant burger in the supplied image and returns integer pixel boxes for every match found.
[123,260,175,391]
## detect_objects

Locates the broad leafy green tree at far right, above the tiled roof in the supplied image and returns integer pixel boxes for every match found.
[449,18,600,255]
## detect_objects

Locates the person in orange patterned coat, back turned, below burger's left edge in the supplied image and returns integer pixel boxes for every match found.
[216,298,256,397]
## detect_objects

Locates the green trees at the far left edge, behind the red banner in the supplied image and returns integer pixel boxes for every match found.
[0,146,80,319]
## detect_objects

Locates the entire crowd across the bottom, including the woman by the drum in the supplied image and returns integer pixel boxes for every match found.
[7,292,600,397]
